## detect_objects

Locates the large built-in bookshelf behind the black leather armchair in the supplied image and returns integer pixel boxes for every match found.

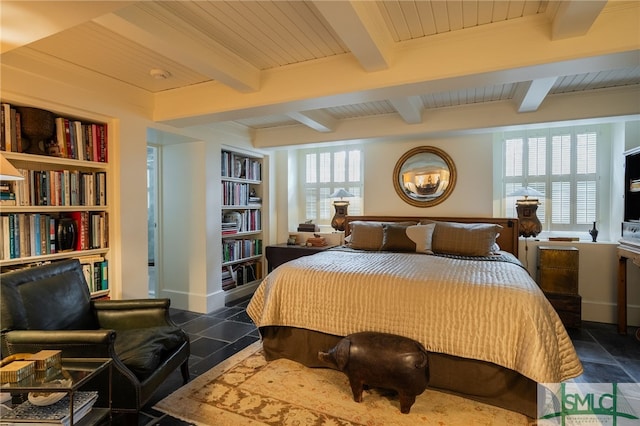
[0,101,110,298]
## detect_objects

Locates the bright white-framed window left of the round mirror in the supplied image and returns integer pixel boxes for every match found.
[300,147,363,225]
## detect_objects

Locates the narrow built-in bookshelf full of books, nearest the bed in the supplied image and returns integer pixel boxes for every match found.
[220,149,264,303]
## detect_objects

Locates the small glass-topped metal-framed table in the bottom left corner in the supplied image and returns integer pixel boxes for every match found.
[0,358,111,425]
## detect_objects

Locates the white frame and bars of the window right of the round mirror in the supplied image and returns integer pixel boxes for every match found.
[494,125,611,239]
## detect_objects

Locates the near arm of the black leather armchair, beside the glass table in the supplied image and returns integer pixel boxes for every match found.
[3,330,116,358]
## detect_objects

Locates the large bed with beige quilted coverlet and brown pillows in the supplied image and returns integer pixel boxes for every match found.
[247,216,582,418]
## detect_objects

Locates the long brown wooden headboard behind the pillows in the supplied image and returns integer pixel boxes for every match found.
[344,216,519,257]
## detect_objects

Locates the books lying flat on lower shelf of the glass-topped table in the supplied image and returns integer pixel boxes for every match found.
[0,391,98,426]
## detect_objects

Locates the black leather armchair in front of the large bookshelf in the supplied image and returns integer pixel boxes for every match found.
[0,260,190,414]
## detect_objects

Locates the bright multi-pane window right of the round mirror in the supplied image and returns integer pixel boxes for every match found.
[502,127,606,232]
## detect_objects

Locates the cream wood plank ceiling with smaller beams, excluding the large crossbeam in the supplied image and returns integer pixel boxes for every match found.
[2,0,640,144]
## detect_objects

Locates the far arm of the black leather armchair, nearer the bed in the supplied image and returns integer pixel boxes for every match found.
[91,299,175,330]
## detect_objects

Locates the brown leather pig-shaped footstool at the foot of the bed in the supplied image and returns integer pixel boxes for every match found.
[318,332,429,414]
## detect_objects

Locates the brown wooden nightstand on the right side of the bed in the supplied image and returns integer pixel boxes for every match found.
[538,246,582,328]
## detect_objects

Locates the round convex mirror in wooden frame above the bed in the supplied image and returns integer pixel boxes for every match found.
[393,146,456,207]
